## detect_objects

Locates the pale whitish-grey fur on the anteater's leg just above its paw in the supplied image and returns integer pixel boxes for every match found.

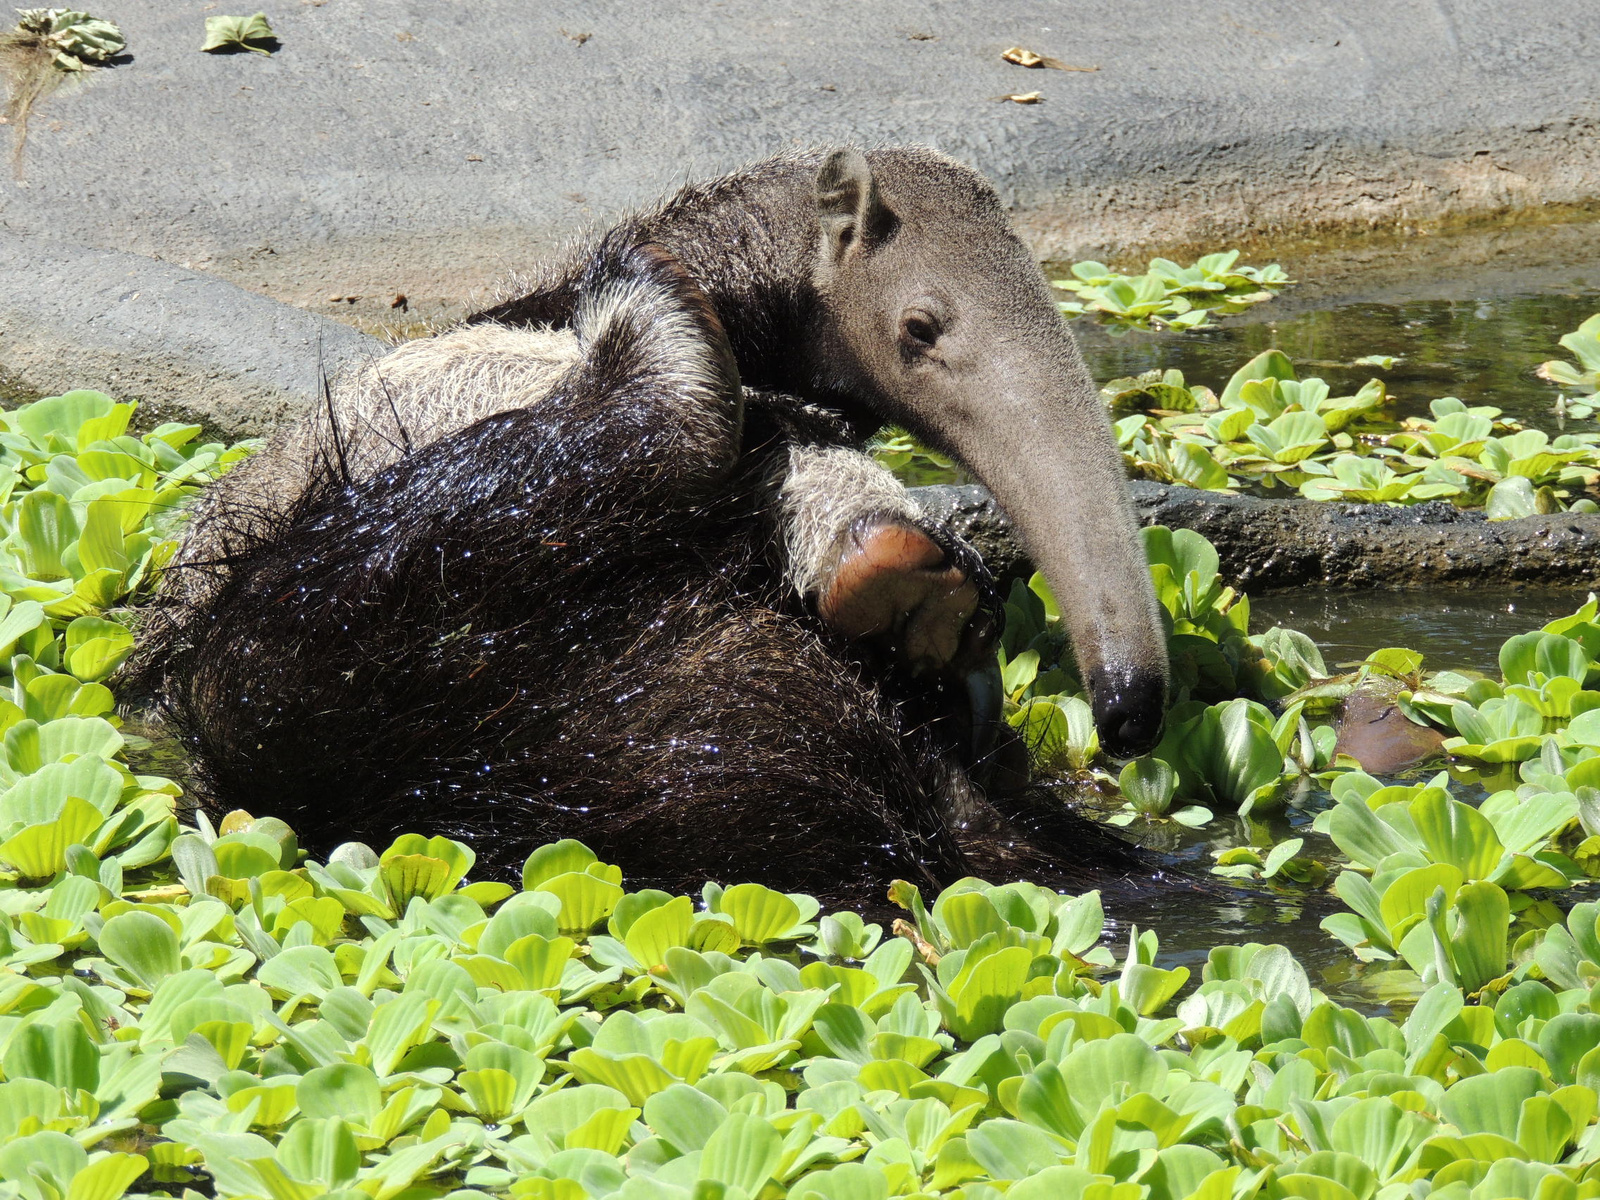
[778,445,926,602]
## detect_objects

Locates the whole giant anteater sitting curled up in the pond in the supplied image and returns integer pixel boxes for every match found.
[144,150,1166,906]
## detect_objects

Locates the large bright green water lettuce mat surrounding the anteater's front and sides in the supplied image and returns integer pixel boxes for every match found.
[0,394,1600,1200]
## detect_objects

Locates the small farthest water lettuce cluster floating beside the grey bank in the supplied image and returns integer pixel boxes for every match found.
[1053,250,1293,330]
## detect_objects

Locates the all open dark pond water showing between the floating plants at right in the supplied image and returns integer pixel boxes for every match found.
[1049,221,1600,1011]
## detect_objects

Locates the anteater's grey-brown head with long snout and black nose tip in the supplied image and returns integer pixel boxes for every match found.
[813,149,1166,755]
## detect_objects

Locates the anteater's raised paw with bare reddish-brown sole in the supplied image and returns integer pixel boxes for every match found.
[818,517,998,675]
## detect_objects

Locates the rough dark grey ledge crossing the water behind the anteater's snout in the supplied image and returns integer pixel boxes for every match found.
[915,480,1600,592]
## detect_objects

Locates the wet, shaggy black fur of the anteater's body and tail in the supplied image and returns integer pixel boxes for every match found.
[142,237,1150,910]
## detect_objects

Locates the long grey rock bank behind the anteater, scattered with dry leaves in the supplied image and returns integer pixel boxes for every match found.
[0,0,1600,320]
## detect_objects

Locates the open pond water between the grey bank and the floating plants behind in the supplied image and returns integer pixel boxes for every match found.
[1053,221,1600,434]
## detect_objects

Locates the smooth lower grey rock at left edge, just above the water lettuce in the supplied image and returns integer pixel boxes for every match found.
[0,234,384,437]
